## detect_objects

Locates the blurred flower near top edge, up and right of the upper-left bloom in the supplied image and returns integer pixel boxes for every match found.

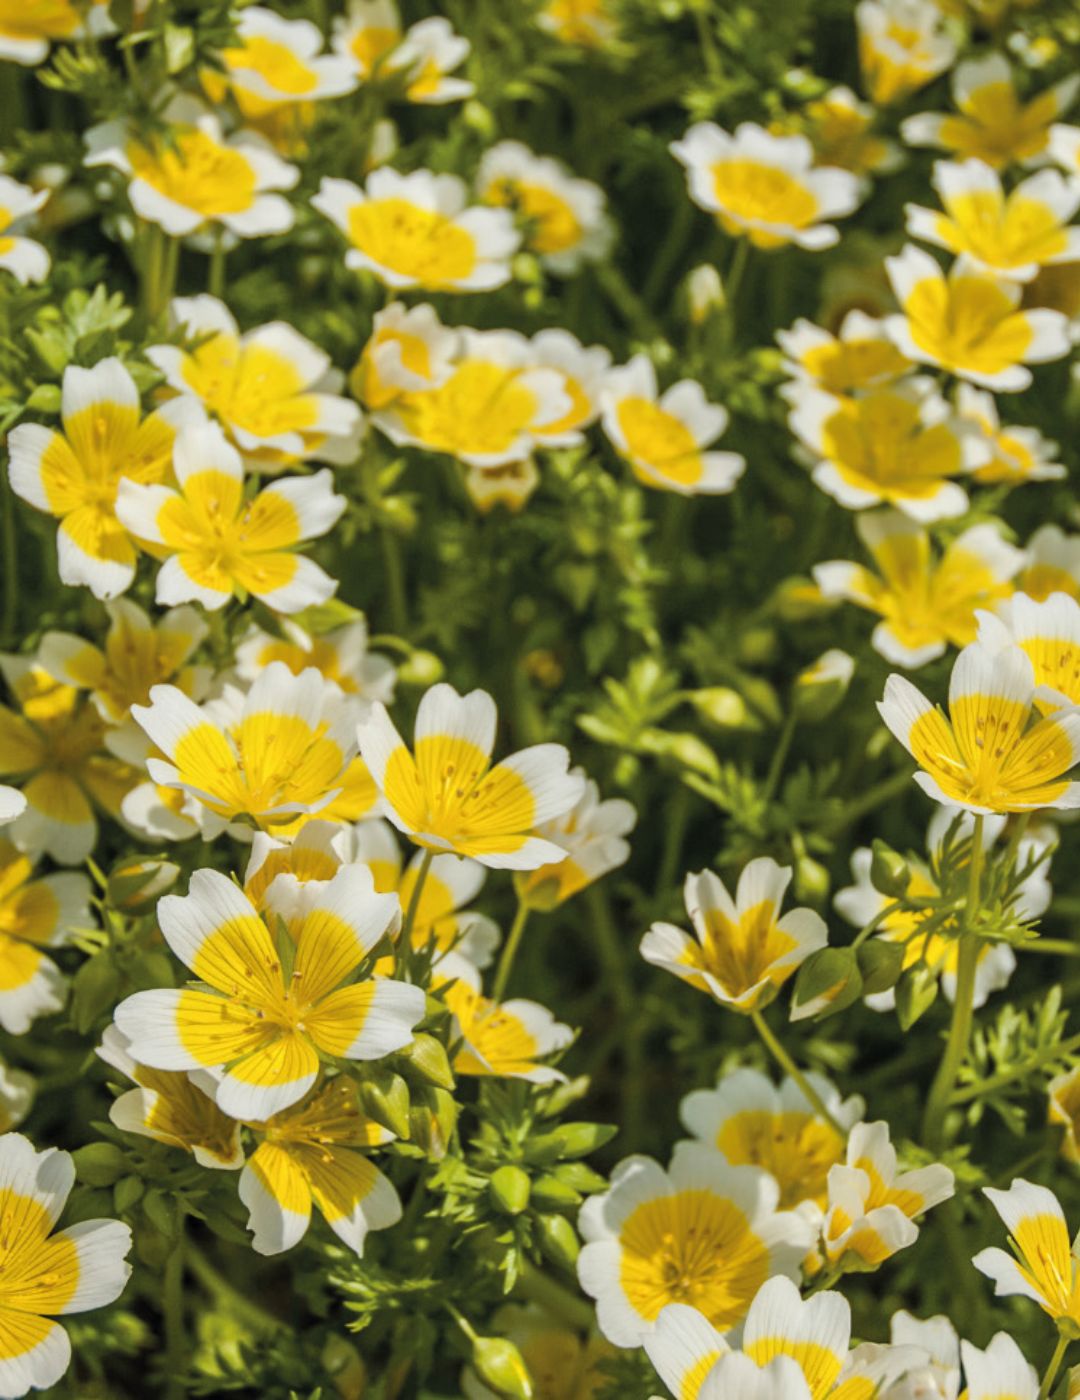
[200,4,357,134]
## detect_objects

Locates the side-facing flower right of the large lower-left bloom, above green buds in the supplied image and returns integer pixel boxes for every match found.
[433,952,574,1084]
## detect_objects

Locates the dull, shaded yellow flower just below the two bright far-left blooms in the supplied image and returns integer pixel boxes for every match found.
[38,598,210,725]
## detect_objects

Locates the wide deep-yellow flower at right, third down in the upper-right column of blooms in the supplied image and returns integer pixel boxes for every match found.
[787,377,990,524]
